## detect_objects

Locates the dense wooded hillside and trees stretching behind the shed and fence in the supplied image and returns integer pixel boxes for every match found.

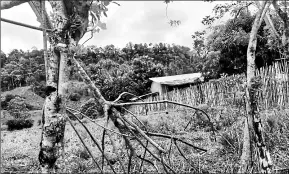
[1,3,280,100]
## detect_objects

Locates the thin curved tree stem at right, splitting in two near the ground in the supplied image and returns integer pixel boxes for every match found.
[240,1,272,173]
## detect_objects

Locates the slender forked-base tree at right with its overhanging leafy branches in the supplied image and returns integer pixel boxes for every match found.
[197,1,288,173]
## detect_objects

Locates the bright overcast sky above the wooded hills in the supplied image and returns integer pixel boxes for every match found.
[1,1,219,54]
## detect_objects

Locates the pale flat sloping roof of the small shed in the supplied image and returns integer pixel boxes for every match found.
[150,73,204,86]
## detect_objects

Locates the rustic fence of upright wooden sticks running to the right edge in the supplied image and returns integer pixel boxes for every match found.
[130,63,289,114]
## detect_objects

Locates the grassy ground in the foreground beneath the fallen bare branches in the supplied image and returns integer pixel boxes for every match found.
[1,107,289,173]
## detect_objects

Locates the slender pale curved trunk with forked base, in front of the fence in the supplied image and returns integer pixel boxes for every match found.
[239,1,270,173]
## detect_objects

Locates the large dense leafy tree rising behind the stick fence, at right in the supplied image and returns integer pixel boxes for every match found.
[192,1,280,79]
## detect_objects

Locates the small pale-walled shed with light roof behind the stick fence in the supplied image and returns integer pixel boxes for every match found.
[150,73,204,95]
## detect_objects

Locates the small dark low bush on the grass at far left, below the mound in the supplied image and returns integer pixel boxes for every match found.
[6,119,34,131]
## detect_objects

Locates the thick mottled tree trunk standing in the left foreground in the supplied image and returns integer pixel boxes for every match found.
[39,0,91,173]
